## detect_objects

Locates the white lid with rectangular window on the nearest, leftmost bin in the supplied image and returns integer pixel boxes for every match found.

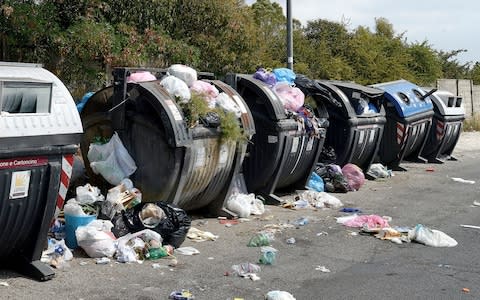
[0,62,83,141]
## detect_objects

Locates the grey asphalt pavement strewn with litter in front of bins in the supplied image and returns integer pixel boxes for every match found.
[0,132,480,300]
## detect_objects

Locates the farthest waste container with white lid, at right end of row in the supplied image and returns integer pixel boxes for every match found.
[422,88,465,163]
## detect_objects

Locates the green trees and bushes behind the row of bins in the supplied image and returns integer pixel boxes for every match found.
[0,0,480,97]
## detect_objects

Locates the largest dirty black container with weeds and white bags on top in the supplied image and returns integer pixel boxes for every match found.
[81,68,254,214]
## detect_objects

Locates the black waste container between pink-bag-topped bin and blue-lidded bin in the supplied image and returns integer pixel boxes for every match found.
[296,80,386,172]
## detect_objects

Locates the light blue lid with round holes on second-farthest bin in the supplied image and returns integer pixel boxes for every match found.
[370,79,433,117]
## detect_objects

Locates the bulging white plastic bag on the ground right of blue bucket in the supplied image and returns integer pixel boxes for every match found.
[75,220,116,258]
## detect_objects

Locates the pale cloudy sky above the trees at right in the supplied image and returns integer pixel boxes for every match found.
[246,0,480,63]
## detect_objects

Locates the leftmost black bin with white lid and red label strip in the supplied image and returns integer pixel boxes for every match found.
[0,62,82,280]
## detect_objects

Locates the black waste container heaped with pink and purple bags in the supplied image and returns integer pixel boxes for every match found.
[226,74,328,203]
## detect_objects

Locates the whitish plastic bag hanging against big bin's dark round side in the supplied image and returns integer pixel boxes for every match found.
[87,132,137,185]
